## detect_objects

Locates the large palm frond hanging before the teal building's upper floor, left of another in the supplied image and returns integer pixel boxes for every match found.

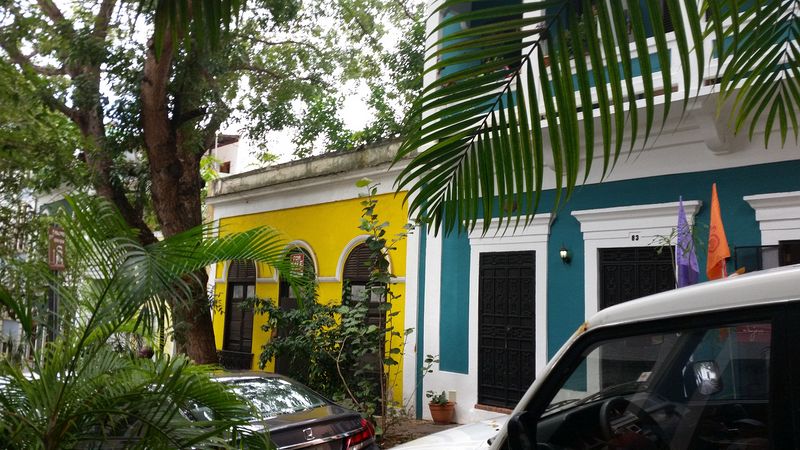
[397,0,702,236]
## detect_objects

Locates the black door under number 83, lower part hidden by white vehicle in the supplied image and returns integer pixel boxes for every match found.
[598,247,675,309]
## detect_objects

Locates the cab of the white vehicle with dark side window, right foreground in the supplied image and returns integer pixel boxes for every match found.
[491,265,800,450]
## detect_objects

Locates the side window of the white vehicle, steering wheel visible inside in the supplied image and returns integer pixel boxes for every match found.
[537,322,772,449]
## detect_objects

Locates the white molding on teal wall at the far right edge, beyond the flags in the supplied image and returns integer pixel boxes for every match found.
[742,191,800,245]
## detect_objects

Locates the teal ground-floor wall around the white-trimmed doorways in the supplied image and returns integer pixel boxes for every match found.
[431,161,800,373]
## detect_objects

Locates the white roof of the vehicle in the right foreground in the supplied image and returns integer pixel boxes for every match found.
[584,264,800,329]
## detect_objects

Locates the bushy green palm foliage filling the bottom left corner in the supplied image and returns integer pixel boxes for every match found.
[0,350,270,448]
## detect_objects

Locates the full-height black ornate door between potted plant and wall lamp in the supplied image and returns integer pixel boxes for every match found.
[478,251,536,408]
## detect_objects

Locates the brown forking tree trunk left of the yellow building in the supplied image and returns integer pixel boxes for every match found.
[23,0,220,363]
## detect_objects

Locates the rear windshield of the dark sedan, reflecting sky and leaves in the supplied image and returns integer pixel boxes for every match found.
[221,377,328,418]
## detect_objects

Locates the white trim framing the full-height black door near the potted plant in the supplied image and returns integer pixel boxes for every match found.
[468,214,552,386]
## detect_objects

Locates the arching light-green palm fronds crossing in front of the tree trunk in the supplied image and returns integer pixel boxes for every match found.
[53,196,308,340]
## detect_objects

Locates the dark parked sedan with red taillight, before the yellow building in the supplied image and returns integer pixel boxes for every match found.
[187,372,378,450]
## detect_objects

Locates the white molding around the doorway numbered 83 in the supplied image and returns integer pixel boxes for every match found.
[572,200,703,318]
